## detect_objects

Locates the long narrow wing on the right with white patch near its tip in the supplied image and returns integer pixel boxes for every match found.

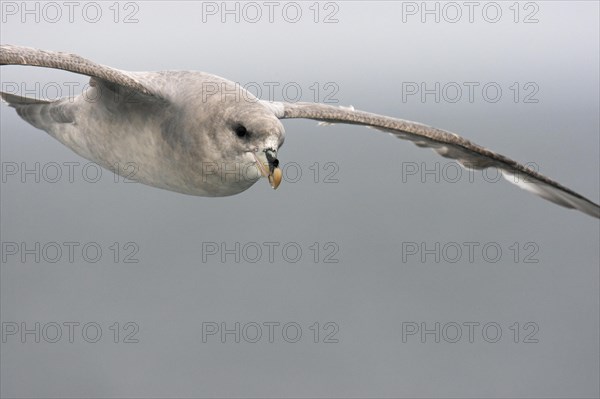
[268,102,600,218]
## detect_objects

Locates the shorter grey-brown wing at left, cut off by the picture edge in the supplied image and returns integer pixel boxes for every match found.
[0,44,155,96]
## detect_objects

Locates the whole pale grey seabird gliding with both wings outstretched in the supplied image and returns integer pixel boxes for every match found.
[0,45,600,218]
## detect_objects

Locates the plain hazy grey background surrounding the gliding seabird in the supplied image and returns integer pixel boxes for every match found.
[0,1,600,398]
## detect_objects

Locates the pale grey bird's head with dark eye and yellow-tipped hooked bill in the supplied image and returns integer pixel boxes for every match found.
[180,76,285,195]
